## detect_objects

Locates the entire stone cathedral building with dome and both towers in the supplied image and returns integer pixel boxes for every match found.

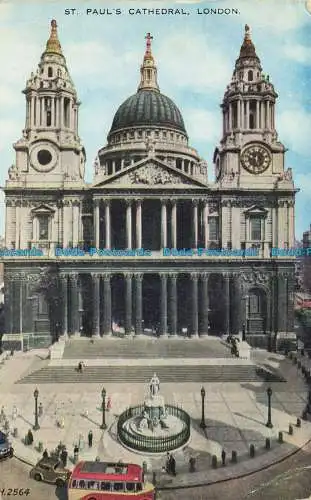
[5,21,296,346]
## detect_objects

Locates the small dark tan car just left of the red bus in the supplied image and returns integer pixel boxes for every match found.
[29,457,71,487]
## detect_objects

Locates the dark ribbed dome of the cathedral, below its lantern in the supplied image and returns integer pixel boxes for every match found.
[110,89,186,134]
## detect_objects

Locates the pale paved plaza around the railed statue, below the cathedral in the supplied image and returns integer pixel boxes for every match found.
[0,338,311,491]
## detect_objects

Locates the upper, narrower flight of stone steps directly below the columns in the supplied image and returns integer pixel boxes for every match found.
[63,338,231,359]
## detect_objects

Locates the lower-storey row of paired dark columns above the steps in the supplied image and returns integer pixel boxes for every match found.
[61,272,239,337]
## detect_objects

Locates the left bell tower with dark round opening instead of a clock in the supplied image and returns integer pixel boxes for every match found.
[7,20,85,187]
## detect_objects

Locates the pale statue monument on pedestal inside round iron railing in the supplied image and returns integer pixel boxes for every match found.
[118,373,190,453]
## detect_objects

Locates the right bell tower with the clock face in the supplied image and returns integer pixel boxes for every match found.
[214,25,285,189]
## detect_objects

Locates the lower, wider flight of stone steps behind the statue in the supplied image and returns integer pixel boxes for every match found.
[17,365,285,384]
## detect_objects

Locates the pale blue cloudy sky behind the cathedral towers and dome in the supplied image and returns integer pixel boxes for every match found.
[0,0,311,239]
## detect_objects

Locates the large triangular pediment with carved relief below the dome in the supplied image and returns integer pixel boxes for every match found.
[93,157,207,187]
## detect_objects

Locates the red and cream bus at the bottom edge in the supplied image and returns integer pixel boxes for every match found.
[68,461,155,500]
